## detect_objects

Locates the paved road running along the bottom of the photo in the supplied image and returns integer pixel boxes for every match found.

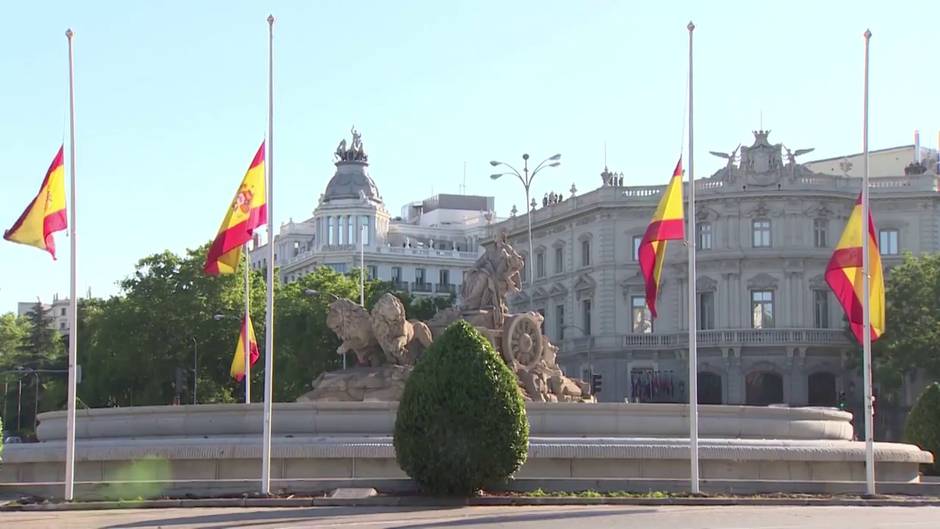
[0,506,940,529]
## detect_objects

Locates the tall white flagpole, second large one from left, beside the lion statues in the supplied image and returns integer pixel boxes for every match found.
[261,15,275,495]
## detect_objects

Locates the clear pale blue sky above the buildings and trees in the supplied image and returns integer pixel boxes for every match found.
[0,0,940,312]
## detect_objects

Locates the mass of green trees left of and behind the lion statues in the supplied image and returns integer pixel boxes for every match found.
[0,245,454,430]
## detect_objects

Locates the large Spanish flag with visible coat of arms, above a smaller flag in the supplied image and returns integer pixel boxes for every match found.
[203,142,268,276]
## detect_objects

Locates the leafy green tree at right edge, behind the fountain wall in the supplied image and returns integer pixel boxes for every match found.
[873,253,940,396]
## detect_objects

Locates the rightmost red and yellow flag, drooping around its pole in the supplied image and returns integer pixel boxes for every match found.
[826,195,885,343]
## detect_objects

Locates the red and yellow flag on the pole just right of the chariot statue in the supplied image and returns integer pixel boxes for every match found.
[637,158,685,318]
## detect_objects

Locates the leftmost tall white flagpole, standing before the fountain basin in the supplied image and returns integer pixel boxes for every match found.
[65,29,78,501]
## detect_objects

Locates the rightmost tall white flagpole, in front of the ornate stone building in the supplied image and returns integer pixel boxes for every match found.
[861,30,875,495]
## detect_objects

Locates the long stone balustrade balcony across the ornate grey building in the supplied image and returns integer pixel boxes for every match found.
[564,329,853,353]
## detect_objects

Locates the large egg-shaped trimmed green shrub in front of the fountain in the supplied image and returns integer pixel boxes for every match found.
[395,320,529,495]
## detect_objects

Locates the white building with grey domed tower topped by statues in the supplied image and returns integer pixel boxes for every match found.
[251,130,494,296]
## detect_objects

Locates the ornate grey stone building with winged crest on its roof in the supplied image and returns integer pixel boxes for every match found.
[494,131,940,438]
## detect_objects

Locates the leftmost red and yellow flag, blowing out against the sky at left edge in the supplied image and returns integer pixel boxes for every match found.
[3,147,68,259]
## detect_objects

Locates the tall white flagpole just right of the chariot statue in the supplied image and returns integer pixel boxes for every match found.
[686,21,701,494]
